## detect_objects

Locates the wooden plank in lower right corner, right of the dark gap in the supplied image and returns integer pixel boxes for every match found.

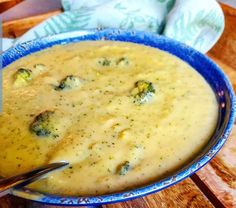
[197,125,236,208]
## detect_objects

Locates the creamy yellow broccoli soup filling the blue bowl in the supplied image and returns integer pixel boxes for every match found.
[0,41,218,195]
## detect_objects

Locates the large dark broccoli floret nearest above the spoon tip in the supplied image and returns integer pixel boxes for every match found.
[30,110,58,137]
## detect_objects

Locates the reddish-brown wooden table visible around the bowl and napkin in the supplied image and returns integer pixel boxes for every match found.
[0,0,236,208]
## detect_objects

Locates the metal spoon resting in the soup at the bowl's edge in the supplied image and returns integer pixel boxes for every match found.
[0,162,69,197]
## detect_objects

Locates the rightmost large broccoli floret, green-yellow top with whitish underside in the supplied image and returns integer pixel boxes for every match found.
[131,80,156,104]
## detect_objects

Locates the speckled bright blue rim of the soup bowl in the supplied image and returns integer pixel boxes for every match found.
[0,29,236,206]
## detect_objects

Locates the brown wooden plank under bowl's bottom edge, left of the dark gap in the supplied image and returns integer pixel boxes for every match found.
[103,179,213,208]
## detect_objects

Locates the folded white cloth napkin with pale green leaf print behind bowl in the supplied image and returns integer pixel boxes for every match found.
[3,0,224,53]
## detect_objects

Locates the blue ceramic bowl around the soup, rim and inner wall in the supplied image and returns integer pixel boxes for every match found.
[2,29,236,206]
